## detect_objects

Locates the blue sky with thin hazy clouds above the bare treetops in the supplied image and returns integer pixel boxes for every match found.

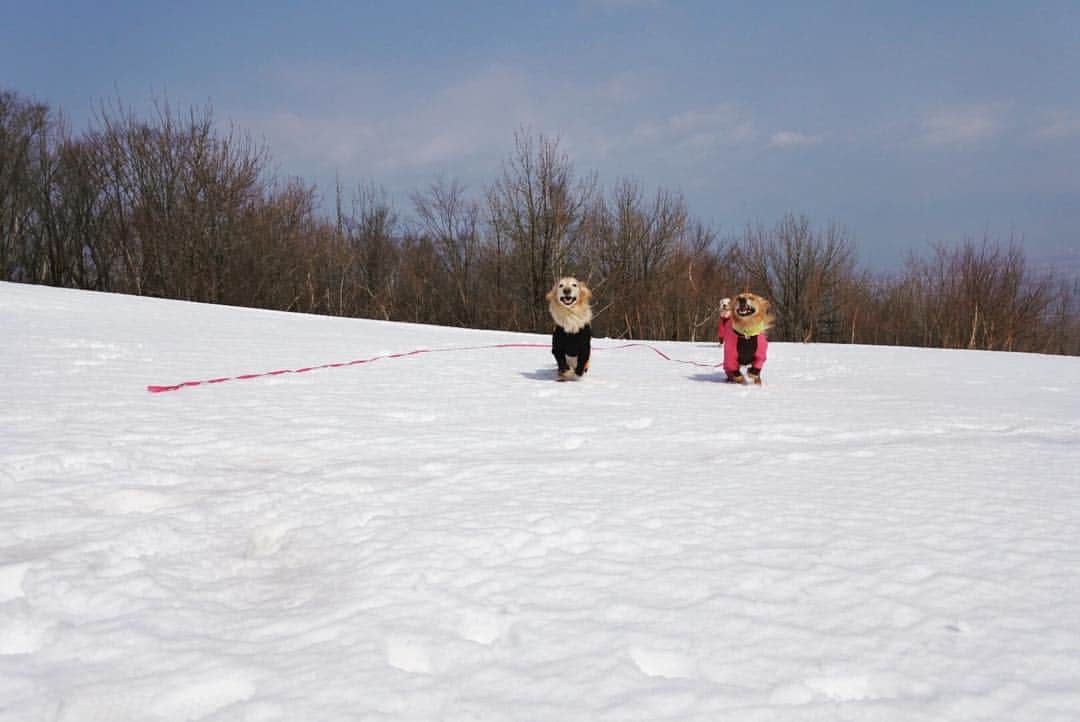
[0,0,1080,268]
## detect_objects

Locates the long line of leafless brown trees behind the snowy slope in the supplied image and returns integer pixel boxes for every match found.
[0,92,1080,355]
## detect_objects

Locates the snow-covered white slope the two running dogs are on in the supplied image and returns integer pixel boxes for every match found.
[6,284,1080,722]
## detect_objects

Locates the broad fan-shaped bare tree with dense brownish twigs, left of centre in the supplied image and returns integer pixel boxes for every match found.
[91,97,266,302]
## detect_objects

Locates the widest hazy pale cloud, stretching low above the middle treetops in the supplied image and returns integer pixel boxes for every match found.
[223,64,781,191]
